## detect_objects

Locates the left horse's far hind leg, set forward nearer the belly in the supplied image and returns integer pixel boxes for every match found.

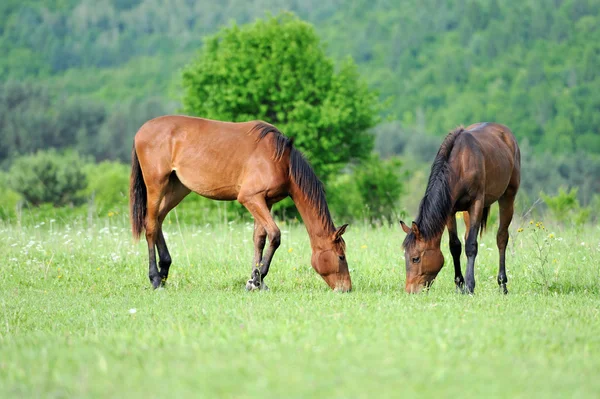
[156,172,190,286]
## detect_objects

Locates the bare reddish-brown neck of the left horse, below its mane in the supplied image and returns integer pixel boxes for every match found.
[290,179,335,250]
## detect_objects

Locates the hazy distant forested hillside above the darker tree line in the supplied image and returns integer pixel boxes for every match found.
[0,0,600,153]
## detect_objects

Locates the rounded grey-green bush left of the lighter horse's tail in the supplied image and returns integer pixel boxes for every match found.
[9,150,87,206]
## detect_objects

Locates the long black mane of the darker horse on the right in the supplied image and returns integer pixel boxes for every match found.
[402,126,465,248]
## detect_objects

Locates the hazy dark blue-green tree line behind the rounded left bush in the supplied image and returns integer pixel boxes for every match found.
[0,81,169,165]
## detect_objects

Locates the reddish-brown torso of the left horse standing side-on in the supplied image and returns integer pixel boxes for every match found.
[135,115,289,200]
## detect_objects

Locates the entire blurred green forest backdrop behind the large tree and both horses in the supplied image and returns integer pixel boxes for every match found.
[0,0,600,223]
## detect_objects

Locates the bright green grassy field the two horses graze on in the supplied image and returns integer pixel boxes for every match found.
[0,216,600,398]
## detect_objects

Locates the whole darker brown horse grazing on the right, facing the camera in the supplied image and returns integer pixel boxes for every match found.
[400,123,521,294]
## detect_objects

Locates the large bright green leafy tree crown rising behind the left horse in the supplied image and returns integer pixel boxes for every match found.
[183,13,380,181]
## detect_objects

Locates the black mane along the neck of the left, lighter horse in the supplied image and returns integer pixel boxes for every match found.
[251,122,335,231]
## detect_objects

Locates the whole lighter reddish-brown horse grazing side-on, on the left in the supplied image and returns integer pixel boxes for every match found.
[130,116,352,291]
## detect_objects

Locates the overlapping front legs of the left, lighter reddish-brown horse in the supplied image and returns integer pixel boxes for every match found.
[238,195,281,290]
